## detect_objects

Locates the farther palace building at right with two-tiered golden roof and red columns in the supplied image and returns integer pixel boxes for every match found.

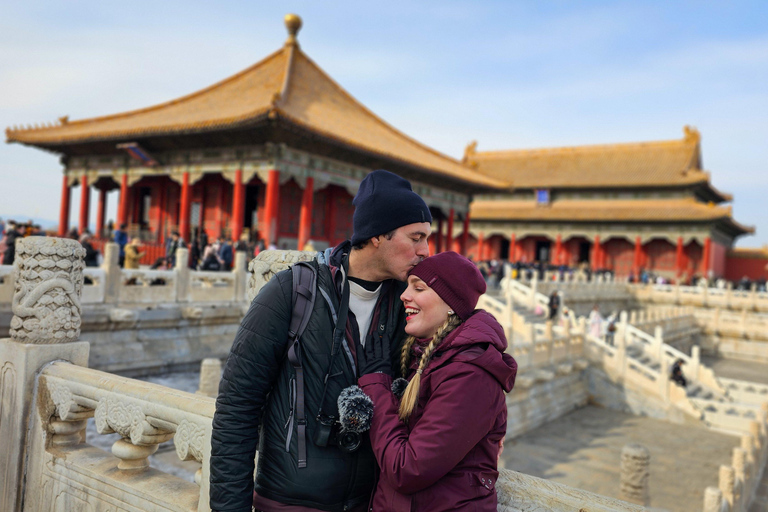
[464,127,754,277]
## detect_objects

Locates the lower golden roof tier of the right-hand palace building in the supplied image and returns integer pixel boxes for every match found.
[470,198,754,232]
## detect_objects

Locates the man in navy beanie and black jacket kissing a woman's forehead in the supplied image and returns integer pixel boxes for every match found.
[210,170,432,512]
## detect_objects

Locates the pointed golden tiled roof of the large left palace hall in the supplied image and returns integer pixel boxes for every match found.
[5,35,510,190]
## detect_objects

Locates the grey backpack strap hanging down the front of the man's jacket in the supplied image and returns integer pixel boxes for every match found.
[288,262,317,468]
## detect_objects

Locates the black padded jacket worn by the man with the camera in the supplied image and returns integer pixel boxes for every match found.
[210,244,405,512]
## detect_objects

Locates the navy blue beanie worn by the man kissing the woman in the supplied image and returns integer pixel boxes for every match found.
[352,169,432,245]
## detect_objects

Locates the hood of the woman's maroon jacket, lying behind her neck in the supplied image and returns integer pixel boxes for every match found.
[413,309,517,393]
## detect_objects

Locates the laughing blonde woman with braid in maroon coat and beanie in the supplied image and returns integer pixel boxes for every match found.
[359,252,517,512]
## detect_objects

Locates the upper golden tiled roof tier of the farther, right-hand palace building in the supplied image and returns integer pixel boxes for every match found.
[464,126,712,189]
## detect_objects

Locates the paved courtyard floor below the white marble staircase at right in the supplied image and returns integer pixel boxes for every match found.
[501,406,740,512]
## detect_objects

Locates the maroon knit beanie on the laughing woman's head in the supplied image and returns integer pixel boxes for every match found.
[408,251,485,320]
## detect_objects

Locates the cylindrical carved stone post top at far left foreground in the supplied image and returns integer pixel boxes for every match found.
[10,237,85,344]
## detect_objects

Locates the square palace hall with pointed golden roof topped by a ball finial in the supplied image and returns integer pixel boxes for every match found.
[6,15,509,256]
